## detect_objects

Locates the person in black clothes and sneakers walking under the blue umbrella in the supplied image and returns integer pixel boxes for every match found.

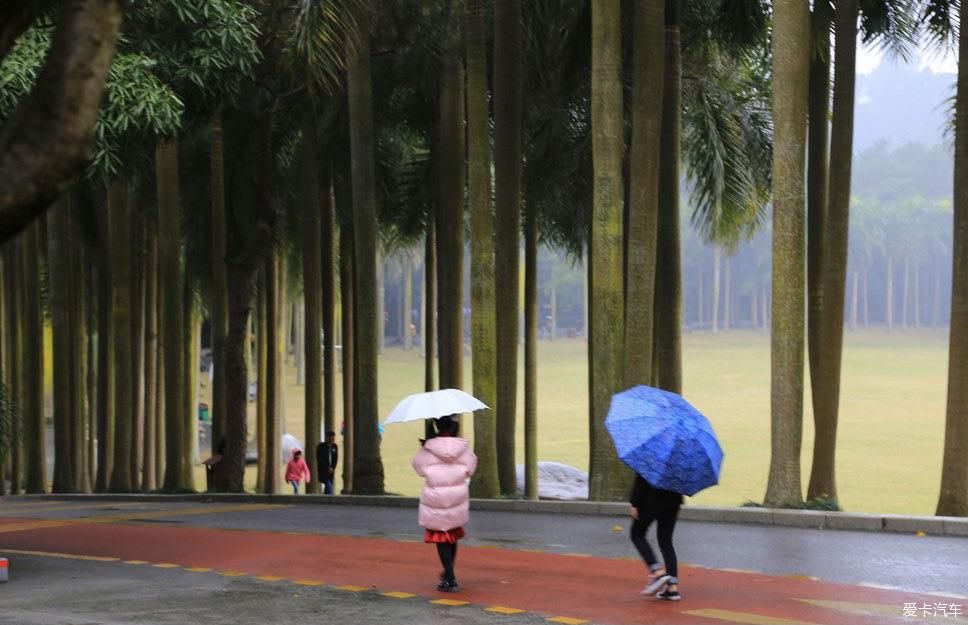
[629,475,682,601]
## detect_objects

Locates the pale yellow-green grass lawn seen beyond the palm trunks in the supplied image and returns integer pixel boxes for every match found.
[233,331,947,514]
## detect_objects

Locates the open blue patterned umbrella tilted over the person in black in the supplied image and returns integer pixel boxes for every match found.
[605,386,723,496]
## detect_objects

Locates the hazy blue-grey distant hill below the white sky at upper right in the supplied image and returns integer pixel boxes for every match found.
[854,59,955,153]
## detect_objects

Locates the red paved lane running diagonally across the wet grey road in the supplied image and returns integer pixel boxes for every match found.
[0,518,943,625]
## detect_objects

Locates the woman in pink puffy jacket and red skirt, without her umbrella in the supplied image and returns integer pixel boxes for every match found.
[412,417,477,592]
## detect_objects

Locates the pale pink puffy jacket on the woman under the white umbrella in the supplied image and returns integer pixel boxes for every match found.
[412,436,477,532]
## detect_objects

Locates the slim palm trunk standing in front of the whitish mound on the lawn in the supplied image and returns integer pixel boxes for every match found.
[524,197,540,501]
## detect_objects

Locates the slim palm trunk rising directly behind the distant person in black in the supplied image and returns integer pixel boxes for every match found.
[322,173,337,442]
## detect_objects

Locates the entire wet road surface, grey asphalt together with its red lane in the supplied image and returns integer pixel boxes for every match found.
[0,498,968,625]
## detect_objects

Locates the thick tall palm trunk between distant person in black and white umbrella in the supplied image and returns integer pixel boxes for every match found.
[346,6,382,494]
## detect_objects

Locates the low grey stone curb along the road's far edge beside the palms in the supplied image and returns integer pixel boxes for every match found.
[0,493,968,538]
